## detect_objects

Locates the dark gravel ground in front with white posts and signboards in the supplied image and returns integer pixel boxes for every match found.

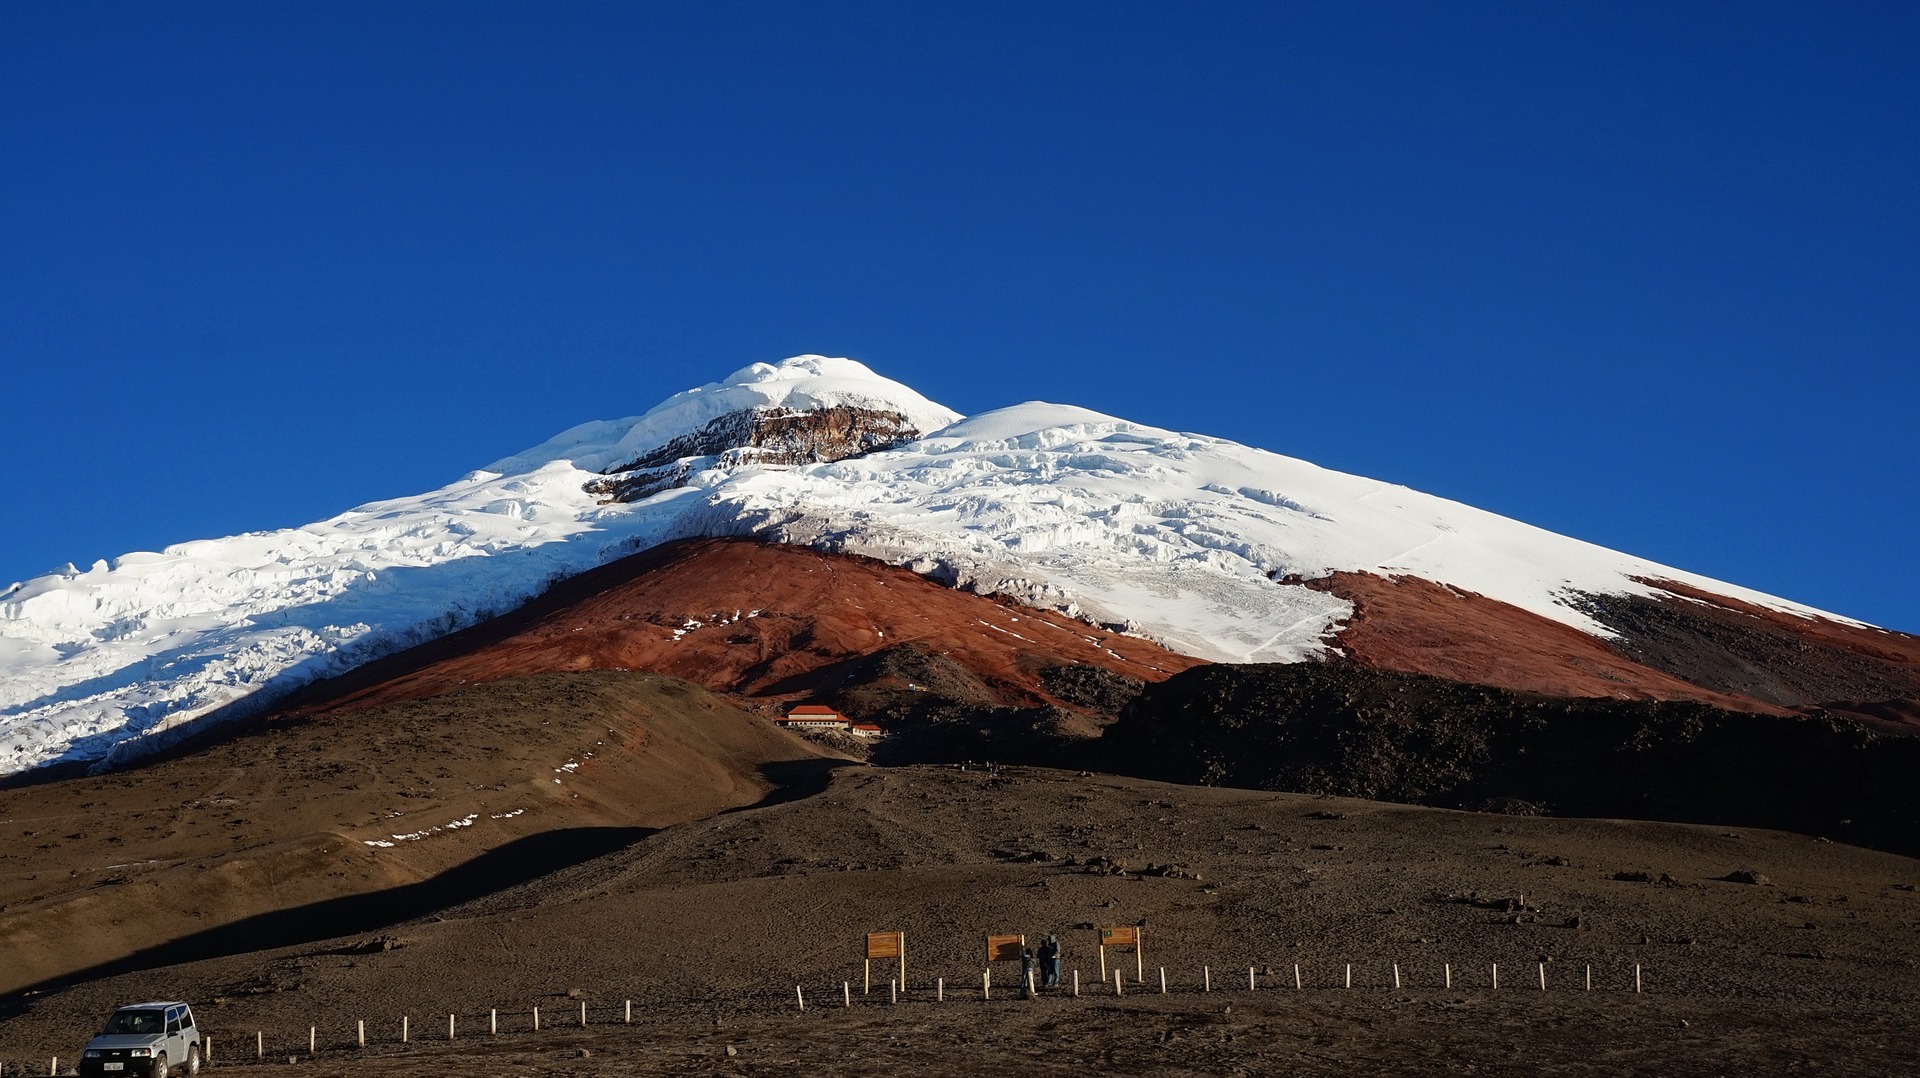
[0,765,1920,1074]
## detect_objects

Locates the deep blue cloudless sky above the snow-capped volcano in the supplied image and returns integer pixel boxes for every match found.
[0,0,1920,630]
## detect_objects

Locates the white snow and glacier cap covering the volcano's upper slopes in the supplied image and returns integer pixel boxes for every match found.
[0,355,1847,774]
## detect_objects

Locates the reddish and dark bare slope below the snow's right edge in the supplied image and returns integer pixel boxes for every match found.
[1306,573,1920,726]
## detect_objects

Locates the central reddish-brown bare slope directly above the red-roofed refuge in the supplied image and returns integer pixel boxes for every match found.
[290,540,1200,711]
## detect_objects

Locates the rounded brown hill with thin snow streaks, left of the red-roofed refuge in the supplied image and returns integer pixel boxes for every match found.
[0,673,820,993]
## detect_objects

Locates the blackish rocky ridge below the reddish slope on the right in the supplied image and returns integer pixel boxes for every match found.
[1100,663,1920,855]
